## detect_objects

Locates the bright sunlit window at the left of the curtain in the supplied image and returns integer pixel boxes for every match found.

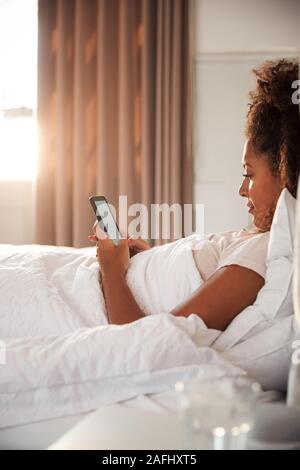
[0,0,37,180]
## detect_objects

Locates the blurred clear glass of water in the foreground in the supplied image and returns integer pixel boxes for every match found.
[176,377,261,450]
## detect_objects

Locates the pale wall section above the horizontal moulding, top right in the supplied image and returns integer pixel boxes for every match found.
[195,0,300,53]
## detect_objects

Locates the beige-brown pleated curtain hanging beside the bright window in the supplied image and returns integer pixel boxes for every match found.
[36,0,192,247]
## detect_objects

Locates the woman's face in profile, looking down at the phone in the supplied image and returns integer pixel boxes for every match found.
[239,141,283,232]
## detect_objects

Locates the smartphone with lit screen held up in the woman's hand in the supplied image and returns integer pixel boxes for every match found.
[89,196,123,245]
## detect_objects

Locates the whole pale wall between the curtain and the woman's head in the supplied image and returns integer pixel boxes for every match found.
[193,0,300,233]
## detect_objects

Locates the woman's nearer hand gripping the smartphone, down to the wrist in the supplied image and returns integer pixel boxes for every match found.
[97,237,129,277]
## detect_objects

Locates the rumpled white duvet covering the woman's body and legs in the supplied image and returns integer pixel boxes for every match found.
[0,235,292,427]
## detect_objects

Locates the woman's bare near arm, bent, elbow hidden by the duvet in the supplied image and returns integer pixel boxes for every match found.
[97,239,264,331]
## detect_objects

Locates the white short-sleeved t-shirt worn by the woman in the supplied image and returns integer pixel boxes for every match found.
[193,229,270,281]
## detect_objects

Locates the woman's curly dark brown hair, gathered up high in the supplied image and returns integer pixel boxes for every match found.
[246,59,300,197]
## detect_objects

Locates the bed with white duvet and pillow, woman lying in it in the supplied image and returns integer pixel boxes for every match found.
[0,190,299,448]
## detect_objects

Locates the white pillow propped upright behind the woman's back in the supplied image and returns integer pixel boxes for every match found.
[214,189,296,390]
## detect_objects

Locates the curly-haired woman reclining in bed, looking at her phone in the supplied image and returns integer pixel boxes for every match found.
[90,59,300,331]
